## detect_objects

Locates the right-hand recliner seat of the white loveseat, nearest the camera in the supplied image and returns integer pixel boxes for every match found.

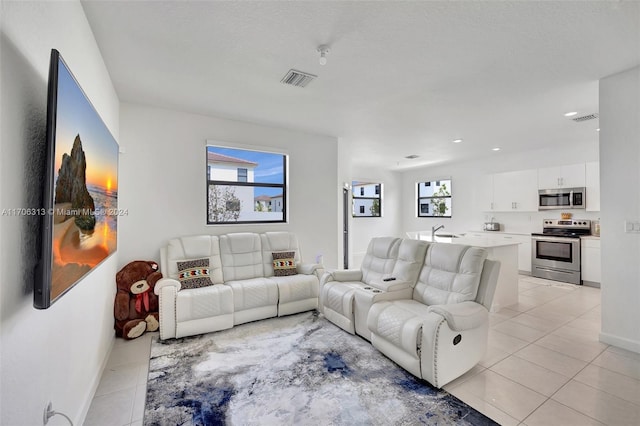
[367,243,500,388]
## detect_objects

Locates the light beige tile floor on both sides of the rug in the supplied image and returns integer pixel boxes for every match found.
[84,276,640,426]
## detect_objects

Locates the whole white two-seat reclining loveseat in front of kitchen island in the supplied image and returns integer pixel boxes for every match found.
[320,238,500,388]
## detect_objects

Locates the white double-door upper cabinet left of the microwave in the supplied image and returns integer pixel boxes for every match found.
[490,169,538,212]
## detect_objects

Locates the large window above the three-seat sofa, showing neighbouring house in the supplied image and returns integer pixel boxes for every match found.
[206,146,287,225]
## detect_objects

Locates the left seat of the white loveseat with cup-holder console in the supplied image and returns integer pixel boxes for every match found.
[320,237,429,340]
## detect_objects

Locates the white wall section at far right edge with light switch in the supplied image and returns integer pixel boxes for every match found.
[600,67,640,352]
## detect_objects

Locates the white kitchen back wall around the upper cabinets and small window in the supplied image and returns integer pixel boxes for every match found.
[401,141,599,238]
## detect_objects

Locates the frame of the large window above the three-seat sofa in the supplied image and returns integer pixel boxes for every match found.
[205,141,289,225]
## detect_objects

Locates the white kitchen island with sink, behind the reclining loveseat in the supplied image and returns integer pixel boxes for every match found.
[407,231,520,312]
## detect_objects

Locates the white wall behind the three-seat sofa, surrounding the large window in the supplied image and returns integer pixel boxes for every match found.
[118,104,338,268]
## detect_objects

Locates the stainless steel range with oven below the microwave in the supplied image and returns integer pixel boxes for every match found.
[531,219,591,284]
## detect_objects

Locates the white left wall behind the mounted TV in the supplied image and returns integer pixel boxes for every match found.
[0,1,119,426]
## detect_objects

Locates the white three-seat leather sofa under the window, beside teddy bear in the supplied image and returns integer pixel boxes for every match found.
[154,232,323,339]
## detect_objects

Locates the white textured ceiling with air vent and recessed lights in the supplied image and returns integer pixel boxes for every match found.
[82,1,640,169]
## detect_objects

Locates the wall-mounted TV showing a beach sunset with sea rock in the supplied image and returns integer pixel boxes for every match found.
[34,49,119,309]
